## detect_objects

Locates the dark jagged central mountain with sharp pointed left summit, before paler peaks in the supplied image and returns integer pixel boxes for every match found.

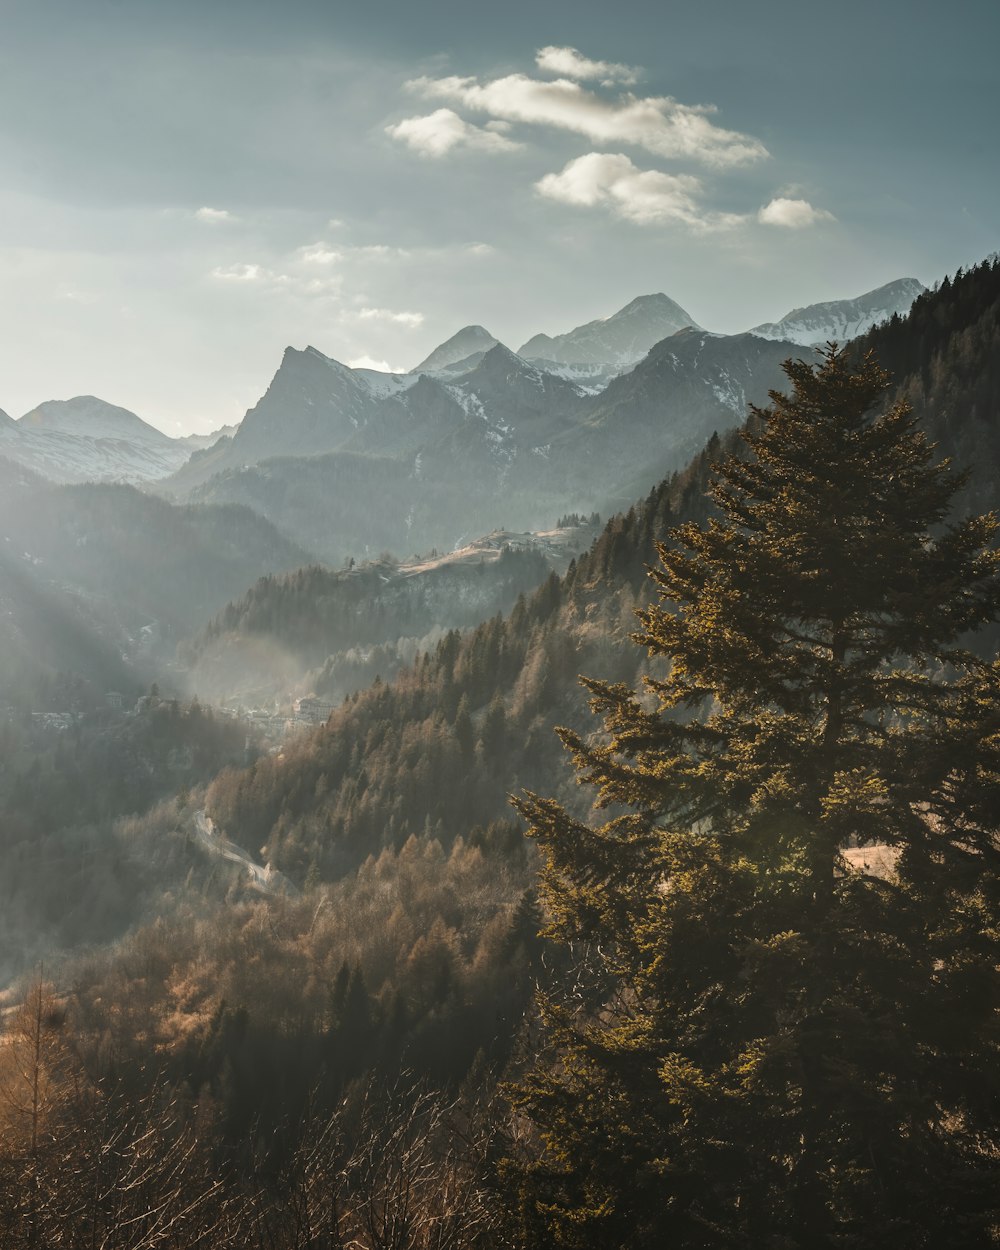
[170,329,790,564]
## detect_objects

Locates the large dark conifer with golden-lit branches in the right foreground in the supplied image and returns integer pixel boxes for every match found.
[508,348,1000,1250]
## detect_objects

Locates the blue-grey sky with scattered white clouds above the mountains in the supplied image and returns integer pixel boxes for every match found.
[0,0,1000,434]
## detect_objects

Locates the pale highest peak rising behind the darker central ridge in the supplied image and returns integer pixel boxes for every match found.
[518,294,700,369]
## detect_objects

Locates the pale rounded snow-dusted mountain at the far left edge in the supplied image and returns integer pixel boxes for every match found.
[0,395,191,483]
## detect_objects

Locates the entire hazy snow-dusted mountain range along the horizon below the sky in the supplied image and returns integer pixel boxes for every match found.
[0,279,923,561]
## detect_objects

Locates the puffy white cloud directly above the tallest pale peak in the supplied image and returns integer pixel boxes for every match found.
[535,153,746,231]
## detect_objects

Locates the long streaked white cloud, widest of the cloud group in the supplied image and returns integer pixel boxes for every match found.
[405,74,768,168]
